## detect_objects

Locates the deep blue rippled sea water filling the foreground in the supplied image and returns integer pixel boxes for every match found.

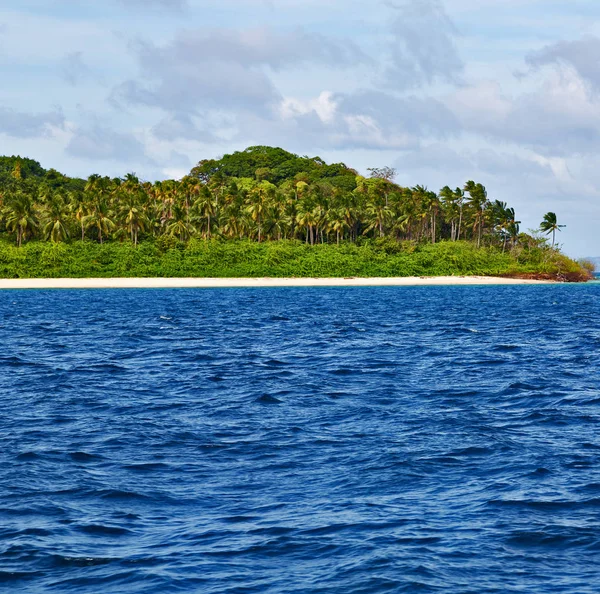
[0,283,600,594]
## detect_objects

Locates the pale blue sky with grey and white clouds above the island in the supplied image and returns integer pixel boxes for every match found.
[0,0,600,257]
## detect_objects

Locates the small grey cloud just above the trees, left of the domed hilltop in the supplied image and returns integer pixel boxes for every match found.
[65,124,151,163]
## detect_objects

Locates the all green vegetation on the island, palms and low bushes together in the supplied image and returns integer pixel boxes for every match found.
[0,146,593,282]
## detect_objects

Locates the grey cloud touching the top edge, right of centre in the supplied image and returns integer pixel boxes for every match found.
[385,0,464,89]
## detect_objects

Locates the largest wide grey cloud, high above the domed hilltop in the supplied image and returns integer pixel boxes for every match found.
[112,28,367,114]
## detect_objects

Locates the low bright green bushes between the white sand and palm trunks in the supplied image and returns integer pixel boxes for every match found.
[0,237,591,280]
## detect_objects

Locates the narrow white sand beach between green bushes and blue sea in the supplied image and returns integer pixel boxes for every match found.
[0,276,551,290]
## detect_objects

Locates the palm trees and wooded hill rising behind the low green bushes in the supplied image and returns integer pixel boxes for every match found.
[0,146,560,251]
